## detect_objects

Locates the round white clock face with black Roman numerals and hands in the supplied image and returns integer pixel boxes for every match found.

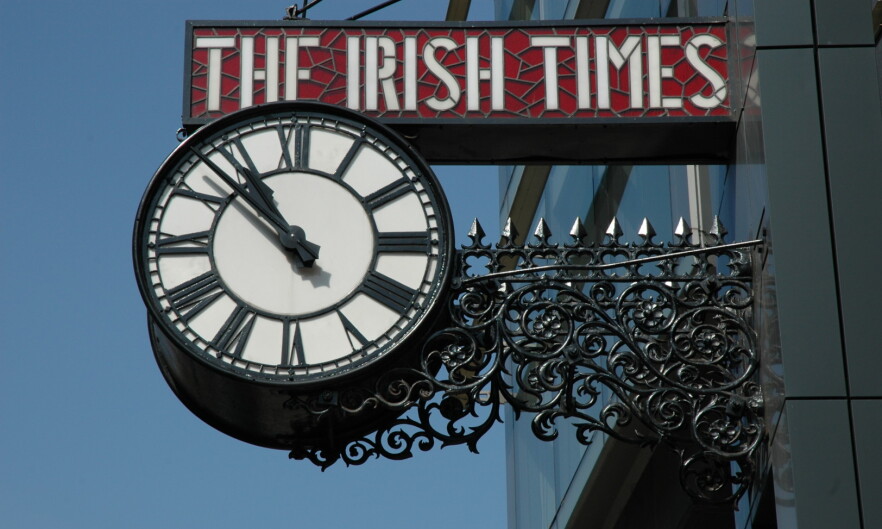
[135,106,451,382]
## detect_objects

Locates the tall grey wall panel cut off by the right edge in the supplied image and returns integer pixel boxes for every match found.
[818,47,882,397]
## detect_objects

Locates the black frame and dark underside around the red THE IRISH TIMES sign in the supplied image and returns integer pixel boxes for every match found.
[182,17,737,164]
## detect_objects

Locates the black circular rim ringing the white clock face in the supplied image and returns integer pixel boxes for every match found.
[132,101,455,388]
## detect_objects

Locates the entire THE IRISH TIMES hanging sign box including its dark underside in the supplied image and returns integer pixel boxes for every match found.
[184,19,733,162]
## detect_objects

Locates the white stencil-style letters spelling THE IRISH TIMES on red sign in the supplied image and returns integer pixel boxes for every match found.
[193,30,728,115]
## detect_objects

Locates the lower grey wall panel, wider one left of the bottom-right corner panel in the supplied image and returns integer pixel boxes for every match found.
[786,399,861,529]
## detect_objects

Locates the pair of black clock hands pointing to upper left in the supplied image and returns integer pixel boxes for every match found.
[190,148,321,268]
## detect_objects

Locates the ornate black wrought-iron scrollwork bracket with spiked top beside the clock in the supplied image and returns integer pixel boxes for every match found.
[290,219,765,501]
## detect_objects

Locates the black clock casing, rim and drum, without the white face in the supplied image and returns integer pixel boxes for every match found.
[133,102,455,449]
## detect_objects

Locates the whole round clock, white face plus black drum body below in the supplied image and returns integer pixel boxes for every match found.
[133,102,454,449]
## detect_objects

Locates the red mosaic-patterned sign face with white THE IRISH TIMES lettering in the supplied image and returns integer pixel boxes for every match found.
[185,21,731,121]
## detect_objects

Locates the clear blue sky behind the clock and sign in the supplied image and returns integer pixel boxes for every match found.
[0,0,505,529]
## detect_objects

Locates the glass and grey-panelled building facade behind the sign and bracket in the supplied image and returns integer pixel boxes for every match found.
[488,0,882,529]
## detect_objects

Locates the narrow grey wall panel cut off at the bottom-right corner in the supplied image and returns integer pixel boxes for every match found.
[851,399,882,529]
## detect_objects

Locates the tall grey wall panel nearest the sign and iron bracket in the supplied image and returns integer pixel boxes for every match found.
[757,49,846,396]
